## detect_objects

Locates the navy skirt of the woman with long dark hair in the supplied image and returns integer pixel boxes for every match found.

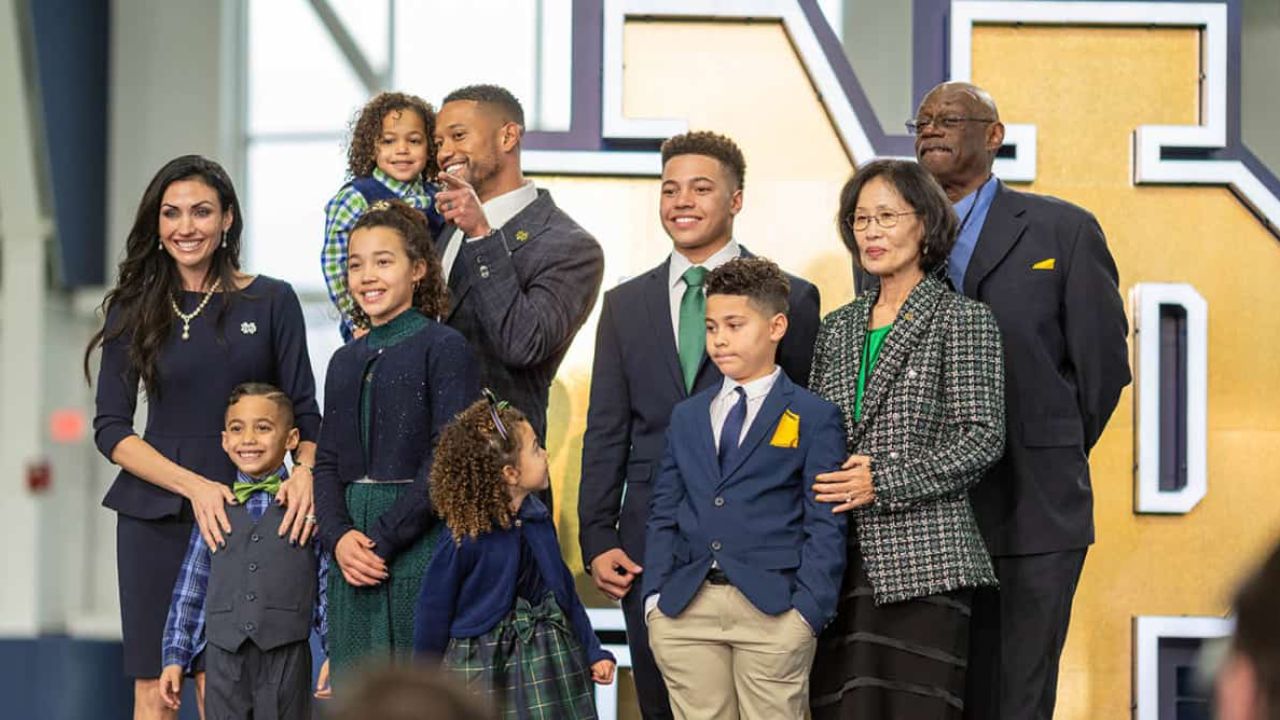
[115,502,195,679]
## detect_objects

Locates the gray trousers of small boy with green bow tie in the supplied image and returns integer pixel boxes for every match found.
[205,641,311,720]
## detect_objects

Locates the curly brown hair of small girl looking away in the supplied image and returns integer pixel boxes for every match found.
[431,400,529,543]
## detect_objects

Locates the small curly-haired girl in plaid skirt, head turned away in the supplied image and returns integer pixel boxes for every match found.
[413,391,614,719]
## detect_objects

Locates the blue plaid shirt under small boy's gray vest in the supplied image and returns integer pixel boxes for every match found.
[161,466,329,671]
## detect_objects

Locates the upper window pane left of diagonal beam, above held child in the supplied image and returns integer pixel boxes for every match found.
[248,0,367,135]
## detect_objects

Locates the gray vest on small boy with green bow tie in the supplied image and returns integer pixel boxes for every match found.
[205,502,317,652]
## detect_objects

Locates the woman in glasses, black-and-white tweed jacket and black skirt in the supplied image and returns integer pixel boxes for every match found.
[809,160,1005,720]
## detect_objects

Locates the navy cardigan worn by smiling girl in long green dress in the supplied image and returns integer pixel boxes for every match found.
[315,310,480,559]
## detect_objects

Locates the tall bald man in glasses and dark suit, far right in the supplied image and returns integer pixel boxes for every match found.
[910,82,1130,720]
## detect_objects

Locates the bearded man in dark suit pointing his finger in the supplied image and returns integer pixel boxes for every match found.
[433,85,604,450]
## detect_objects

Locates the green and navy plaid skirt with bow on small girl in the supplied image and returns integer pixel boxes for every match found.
[444,593,595,720]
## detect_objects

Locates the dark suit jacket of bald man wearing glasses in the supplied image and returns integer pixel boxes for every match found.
[860,183,1130,555]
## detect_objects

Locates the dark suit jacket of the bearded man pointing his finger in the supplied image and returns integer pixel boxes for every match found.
[436,190,604,442]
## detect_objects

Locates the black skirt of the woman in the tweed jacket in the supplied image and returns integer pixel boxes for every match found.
[809,539,973,720]
